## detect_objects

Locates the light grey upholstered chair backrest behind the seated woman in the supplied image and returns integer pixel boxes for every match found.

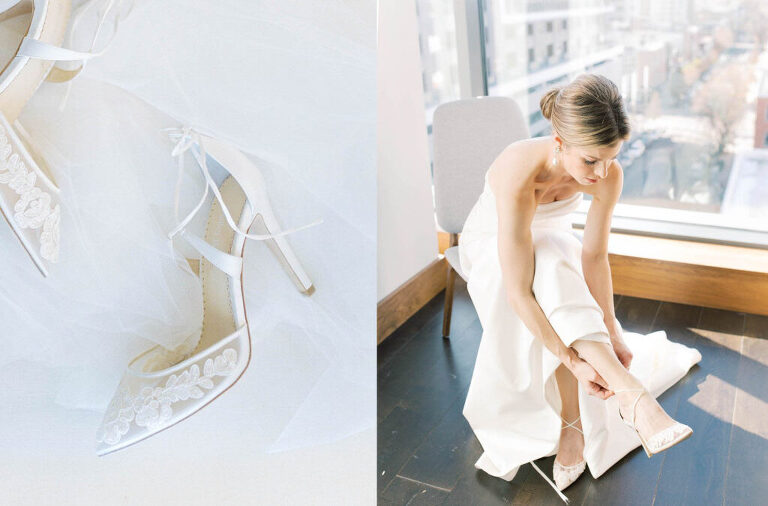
[432,97,530,234]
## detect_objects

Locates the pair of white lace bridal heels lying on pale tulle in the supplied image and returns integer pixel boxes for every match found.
[0,0,317,455]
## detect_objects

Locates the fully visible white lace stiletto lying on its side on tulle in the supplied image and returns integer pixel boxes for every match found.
[96,125,321,455]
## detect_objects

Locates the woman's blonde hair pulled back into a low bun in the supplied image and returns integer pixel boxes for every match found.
[539,74,631,147]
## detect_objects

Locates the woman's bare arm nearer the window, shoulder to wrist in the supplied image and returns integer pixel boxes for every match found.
[581,161,624,339]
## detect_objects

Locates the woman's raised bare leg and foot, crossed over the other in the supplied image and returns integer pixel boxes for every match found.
[571,339,674,437]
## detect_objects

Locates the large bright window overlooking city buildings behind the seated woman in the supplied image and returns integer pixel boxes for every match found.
[417,0,768,247]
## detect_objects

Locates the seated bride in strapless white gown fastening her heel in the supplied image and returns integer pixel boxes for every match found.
[459,74,701,504]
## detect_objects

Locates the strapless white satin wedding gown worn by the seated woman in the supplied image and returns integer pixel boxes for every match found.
[459,169,701,498]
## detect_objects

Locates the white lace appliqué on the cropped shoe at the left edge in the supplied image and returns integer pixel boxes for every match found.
[0,125,60,262]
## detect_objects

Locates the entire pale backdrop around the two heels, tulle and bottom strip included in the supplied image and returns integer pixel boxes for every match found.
[0,0,376,504]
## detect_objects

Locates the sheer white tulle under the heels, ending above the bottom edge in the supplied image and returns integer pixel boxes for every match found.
[0,0,376,453]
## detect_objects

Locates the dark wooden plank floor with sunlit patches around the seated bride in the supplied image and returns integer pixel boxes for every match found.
[378,280,768,506]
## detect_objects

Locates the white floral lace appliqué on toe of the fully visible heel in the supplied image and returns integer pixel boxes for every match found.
[96,348,237,444]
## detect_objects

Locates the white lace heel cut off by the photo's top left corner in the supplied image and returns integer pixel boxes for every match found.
[0,0,121,276]
